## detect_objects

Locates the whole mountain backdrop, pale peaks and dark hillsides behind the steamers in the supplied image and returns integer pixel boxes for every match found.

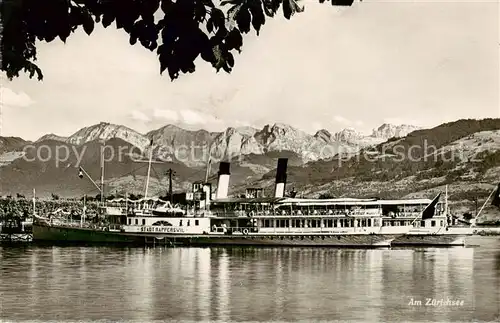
[0,119,500,223]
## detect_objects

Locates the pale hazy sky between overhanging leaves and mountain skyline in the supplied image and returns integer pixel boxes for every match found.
[0,0,500,140]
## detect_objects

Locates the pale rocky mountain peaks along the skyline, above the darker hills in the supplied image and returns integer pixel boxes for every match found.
[30,122,419,167]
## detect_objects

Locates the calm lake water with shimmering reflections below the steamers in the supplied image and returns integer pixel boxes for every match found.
[0,237,500,322]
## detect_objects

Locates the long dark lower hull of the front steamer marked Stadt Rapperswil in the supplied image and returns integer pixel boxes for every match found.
[33,224,396,248]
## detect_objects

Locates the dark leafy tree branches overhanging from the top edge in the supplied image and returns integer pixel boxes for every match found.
[0,0,354,81]
